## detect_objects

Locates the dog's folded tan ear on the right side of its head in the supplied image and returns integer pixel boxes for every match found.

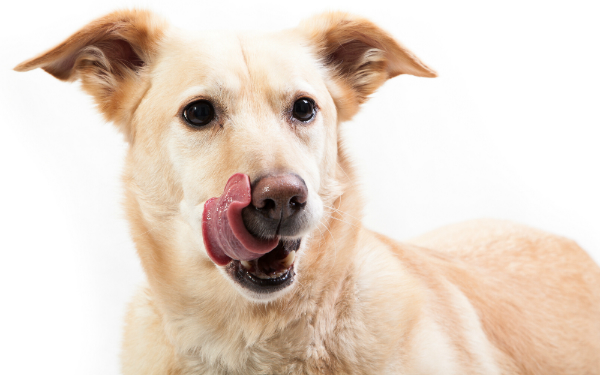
[299,12,437,120]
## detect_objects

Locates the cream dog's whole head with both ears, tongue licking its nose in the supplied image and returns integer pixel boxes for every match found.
[16,11,435,300]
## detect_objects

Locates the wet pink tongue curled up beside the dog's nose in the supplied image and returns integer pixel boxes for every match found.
[202,173,279,266]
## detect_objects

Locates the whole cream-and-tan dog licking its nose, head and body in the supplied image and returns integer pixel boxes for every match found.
[15,10,600,375]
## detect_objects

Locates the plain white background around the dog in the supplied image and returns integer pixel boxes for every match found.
[0,0,600,375]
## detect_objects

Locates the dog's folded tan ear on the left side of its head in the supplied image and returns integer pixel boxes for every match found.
[15,10,166,141]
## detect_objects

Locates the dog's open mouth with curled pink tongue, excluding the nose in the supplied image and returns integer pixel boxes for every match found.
[202,173,301,293]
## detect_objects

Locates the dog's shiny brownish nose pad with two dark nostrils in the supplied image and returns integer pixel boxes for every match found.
[252,174,308,221]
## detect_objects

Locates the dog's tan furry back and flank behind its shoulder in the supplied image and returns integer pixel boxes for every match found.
[406,220,600,374]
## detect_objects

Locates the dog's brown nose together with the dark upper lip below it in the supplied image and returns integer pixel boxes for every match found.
[242,174,308,237]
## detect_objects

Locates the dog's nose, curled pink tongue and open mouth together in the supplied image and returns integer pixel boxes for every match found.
[202,173,308,293]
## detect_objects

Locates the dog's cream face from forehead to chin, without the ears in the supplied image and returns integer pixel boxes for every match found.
[154,33,337,299]
